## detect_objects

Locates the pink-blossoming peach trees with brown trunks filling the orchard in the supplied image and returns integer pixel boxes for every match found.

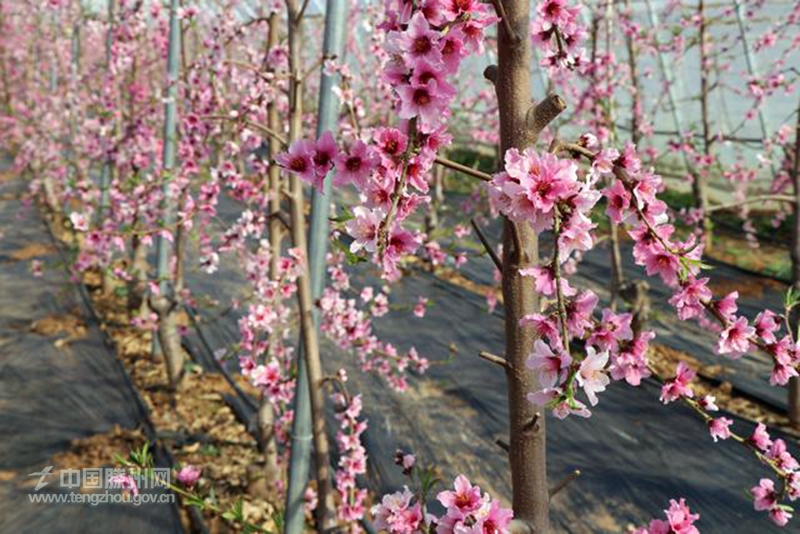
[0,0,800,532]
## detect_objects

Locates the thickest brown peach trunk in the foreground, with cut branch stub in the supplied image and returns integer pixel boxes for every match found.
[495,0,550,534]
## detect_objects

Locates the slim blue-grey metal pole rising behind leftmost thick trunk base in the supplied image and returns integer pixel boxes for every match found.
[153,0,181,360]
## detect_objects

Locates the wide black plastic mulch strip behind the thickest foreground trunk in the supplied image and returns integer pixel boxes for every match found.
[177,197,797,533]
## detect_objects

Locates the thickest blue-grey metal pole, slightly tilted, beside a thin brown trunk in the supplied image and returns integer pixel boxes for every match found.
[286,0,347,534]
